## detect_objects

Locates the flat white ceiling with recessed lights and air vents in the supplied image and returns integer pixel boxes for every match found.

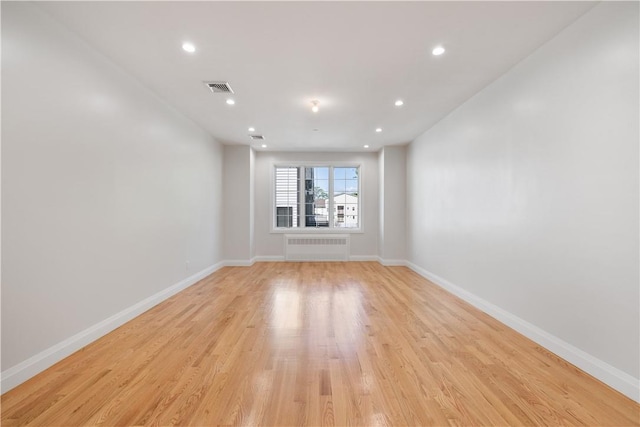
[39,1,595,151]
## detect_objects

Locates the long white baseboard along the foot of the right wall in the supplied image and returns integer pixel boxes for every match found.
[406,261,640,402]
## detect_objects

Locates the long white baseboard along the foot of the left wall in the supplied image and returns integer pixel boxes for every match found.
[0,262,224,393]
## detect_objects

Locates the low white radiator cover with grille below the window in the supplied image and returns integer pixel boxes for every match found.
[284,234,349,261]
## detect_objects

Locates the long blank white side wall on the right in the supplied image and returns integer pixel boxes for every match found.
[407,2,640,399]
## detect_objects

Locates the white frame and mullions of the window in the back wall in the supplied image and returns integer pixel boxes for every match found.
[269,161,364,234]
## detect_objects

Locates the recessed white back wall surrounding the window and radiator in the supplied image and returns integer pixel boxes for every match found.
[254,151,379,260]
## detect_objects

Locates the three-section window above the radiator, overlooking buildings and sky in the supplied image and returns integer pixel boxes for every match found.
[274,166,360,229]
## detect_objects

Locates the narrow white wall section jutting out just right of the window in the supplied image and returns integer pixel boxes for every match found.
[378,145,407,265]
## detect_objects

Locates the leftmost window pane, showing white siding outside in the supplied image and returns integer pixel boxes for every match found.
[276,167,300,228]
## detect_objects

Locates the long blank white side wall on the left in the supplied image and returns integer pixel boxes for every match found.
[2,2,222,388]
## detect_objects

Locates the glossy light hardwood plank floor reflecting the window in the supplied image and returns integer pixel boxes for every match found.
[2,262,640,426]
